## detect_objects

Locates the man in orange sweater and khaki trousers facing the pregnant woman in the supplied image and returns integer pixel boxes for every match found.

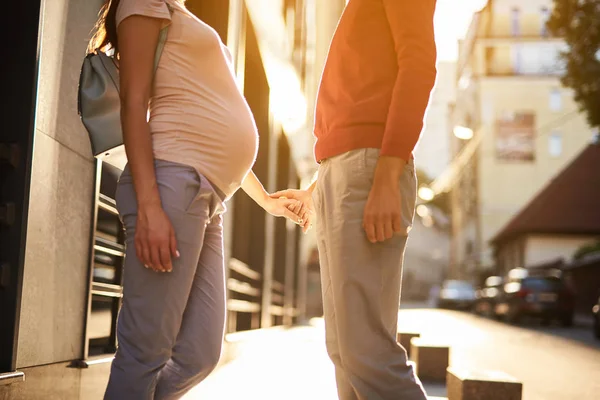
[273,0,436,400]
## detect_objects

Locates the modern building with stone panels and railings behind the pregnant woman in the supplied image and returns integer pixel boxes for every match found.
[0,0,343,400]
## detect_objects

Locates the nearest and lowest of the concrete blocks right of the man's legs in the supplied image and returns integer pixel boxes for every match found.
[446,367,523,400]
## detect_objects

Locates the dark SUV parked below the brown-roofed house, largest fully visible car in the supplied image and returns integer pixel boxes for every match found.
[495,269,575,326]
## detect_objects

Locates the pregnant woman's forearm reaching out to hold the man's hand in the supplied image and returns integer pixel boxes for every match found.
[242,171,304,225]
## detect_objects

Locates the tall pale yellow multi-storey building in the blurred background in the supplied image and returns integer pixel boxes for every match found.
[433,0,593,277]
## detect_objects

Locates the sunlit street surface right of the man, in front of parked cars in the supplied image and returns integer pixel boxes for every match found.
[400,309,600,400]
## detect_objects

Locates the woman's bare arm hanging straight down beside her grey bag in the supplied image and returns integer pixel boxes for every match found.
[118,15,178,272]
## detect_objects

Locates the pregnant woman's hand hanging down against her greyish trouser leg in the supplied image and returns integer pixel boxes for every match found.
[135,204,179,272]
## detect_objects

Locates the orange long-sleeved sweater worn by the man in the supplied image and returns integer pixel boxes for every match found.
[315,0,436,162]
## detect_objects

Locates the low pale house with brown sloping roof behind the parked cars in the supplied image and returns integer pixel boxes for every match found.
[492,141,600,276]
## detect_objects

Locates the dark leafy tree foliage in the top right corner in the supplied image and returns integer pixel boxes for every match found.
[548,0,600,127]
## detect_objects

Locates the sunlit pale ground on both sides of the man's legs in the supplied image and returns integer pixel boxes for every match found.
[185,308,600,400]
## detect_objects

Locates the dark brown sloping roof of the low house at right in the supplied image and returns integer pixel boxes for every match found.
[491,144,600,245]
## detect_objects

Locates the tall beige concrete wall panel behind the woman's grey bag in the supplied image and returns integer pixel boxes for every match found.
[17,0,101,368]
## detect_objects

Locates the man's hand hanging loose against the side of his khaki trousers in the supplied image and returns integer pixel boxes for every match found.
[363,156,406,243]
